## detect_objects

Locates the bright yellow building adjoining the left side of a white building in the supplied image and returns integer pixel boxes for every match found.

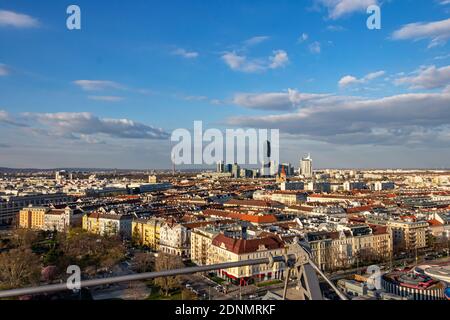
[131,218,164,251]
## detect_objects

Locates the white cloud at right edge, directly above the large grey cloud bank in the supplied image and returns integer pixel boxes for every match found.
[395,66,450,89]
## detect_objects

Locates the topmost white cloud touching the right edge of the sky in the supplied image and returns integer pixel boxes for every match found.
[392,18,450,48]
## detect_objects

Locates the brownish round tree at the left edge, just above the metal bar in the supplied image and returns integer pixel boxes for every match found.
[0,248,41,289]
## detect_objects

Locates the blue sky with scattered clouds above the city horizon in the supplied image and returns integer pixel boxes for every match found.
[0,0,450,169]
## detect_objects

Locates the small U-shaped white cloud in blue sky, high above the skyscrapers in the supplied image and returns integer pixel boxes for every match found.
[222,50,289,73]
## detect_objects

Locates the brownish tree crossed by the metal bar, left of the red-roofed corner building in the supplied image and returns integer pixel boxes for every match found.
[155,253,183,296]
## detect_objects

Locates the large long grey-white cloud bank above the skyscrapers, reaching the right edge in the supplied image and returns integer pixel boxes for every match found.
[228,92,450,146]
